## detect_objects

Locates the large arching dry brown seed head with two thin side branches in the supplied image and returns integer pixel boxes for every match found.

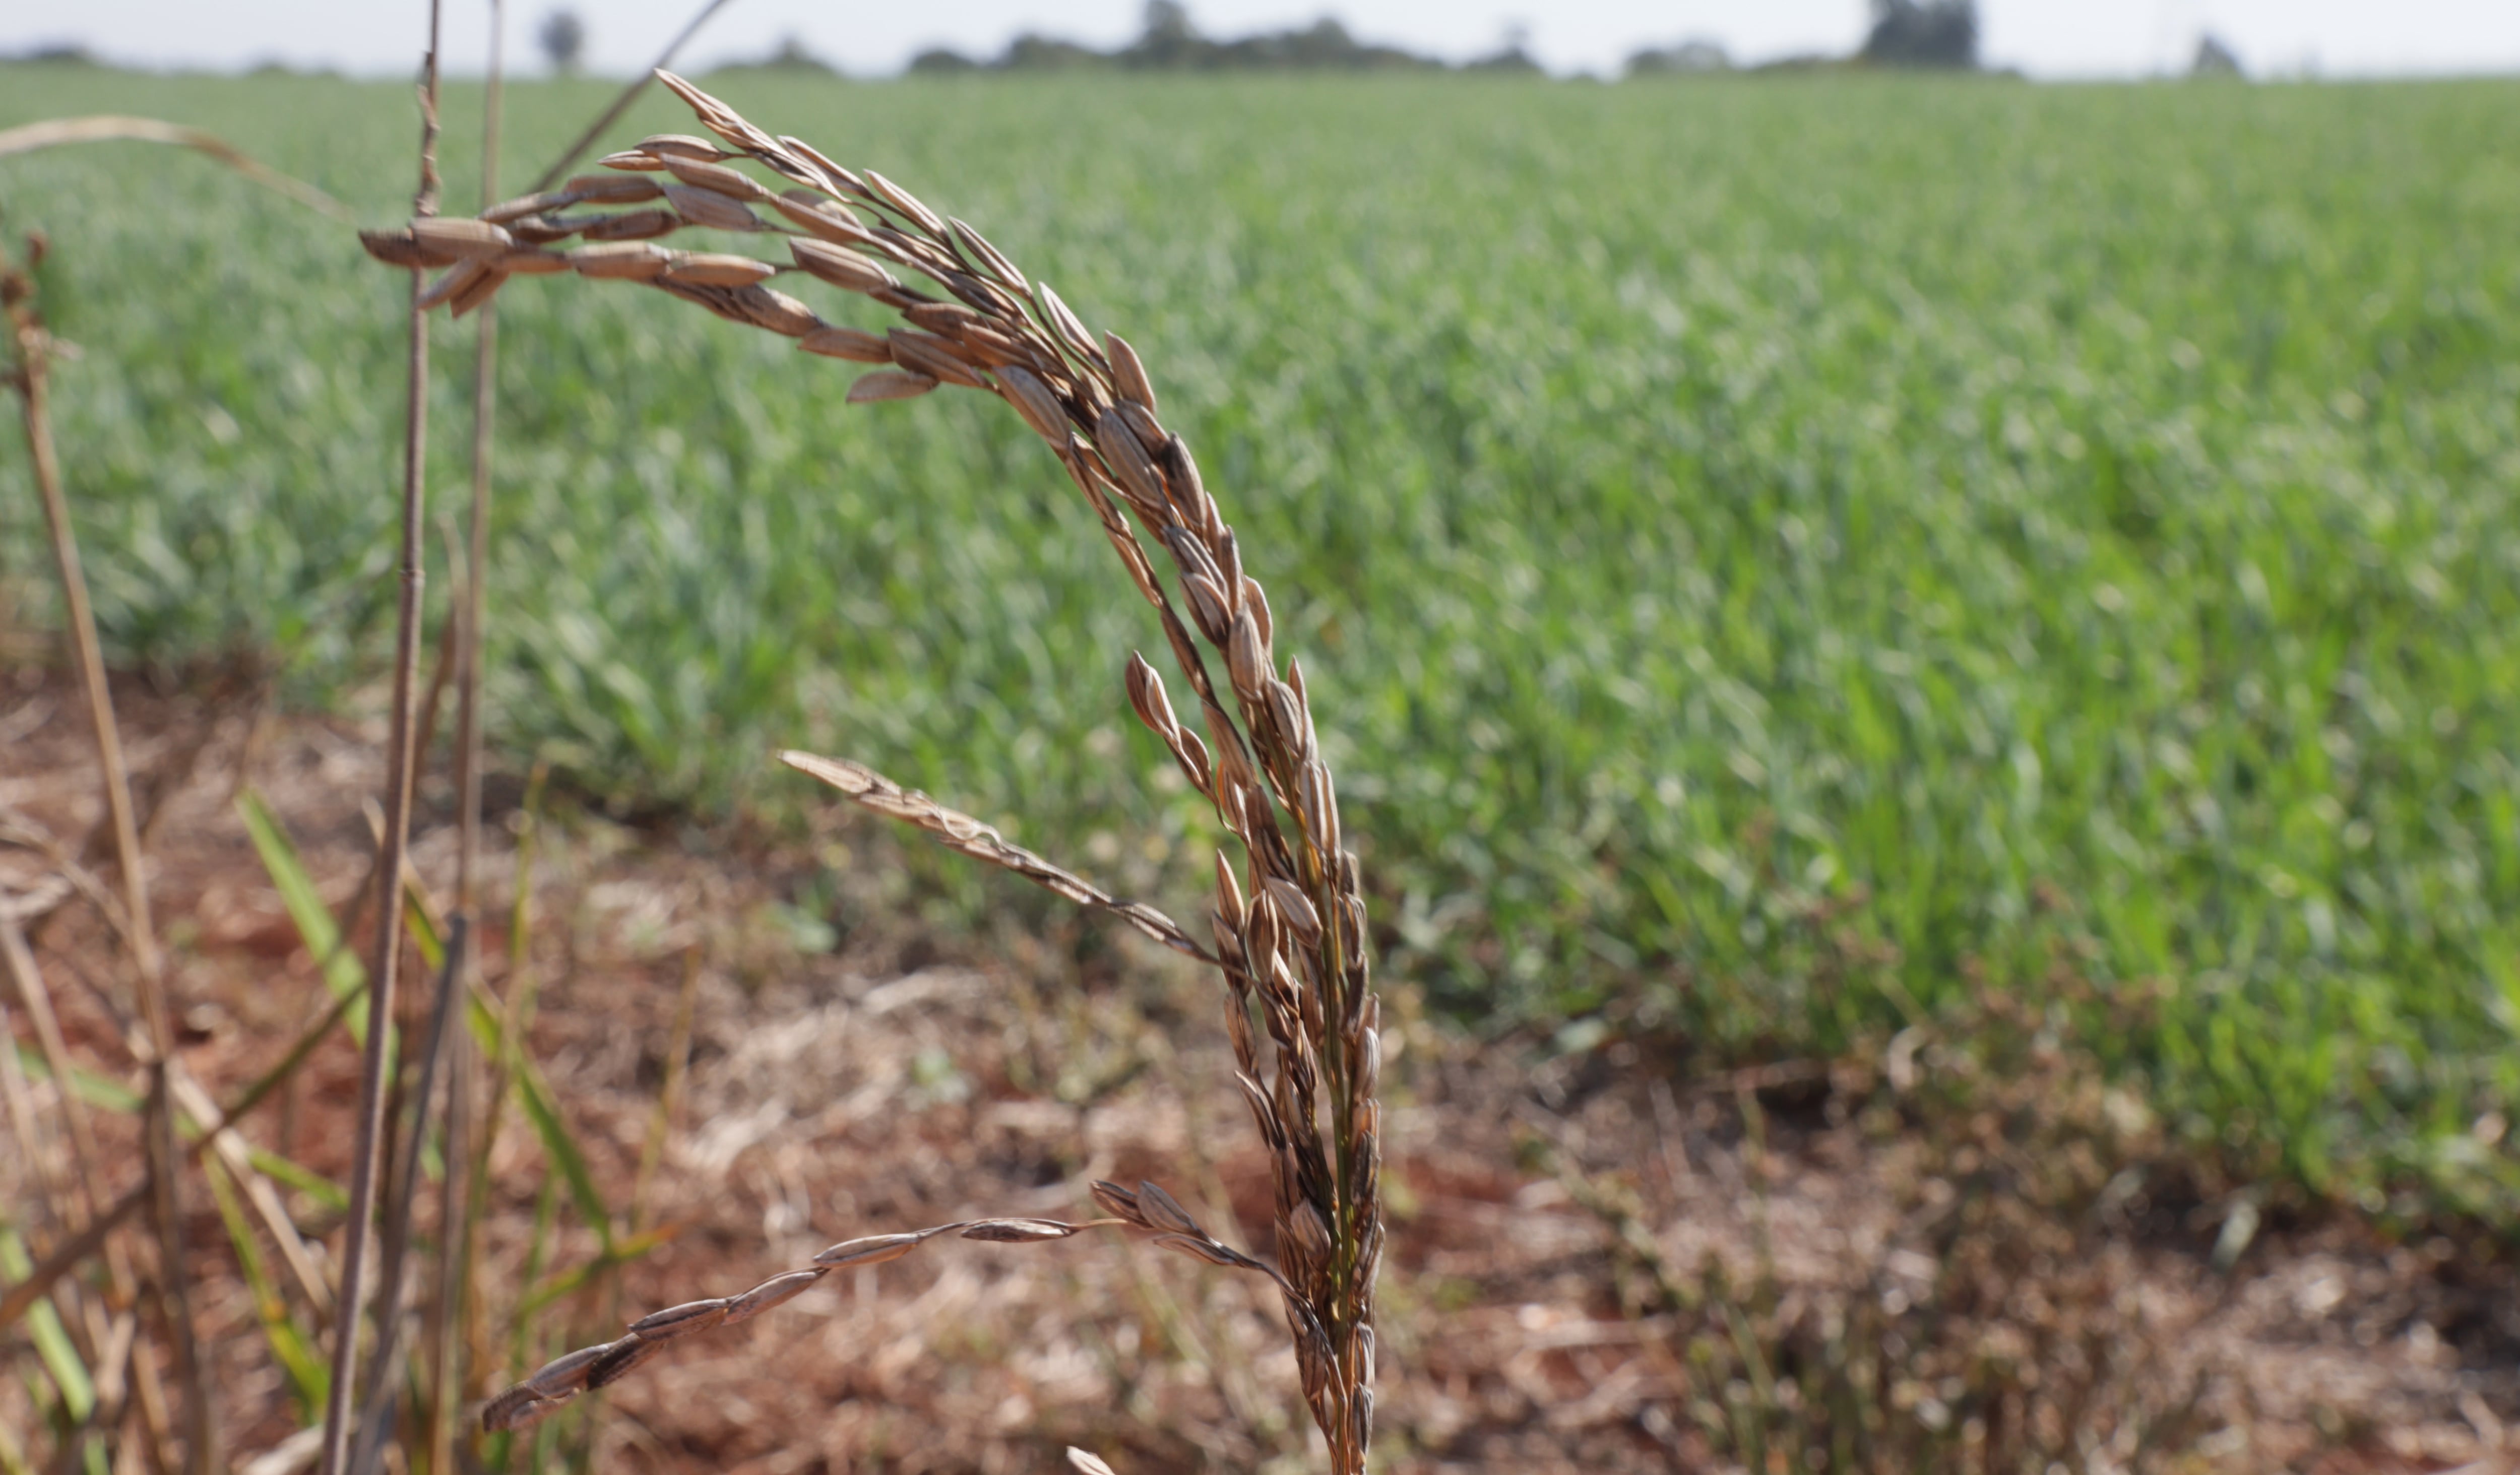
[363,73,1383,1475]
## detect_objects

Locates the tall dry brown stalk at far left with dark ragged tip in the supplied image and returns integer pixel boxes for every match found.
[0,227,219,1475]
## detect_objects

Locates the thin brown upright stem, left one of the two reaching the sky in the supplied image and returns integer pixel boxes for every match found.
[320,11,444,1475]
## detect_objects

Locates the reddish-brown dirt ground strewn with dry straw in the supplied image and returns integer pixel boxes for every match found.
[0,668,2520,1475]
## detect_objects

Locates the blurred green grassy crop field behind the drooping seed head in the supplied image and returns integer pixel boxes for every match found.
[0,68,2520,1195]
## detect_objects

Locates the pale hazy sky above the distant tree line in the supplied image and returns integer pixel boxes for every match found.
[0,0,2520,78]
